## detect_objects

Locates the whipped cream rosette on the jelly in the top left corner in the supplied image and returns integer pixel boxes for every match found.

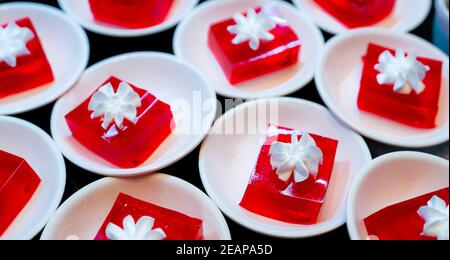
[0,23,34,68]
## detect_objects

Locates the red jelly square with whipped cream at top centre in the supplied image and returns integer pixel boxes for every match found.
[208,6,300,84]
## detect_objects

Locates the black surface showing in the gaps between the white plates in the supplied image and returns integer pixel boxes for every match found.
[0,0,449,241]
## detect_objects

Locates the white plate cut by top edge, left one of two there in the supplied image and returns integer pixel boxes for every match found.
[58,0,199,37]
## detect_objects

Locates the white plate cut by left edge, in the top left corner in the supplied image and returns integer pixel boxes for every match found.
[0,3,89,115]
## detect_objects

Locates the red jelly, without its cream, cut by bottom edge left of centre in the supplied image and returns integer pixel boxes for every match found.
[95,193,203,240]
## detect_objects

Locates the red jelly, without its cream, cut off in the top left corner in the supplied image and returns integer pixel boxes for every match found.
[0,18,54,98]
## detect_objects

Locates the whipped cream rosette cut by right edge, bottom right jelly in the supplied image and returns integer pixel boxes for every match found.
[418,196,449,240]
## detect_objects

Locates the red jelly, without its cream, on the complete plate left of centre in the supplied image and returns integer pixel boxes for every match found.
[66,77,175,168]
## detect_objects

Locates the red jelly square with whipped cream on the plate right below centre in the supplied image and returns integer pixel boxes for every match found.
[240,126,338,225]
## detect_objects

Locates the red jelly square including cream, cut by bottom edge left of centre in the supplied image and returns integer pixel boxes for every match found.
[95,193,203,240]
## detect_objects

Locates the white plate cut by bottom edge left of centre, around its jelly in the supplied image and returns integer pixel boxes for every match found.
[41,174,231,240]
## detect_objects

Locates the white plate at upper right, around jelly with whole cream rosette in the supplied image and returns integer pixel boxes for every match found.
[316,29,449,147]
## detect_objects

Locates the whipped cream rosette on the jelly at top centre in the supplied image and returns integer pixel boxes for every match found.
[228,5,285,51]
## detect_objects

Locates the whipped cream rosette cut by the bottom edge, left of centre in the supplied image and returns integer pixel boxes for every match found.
[106,216,167,240]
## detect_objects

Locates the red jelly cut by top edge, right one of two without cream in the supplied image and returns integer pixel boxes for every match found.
[315,0,396,28]
